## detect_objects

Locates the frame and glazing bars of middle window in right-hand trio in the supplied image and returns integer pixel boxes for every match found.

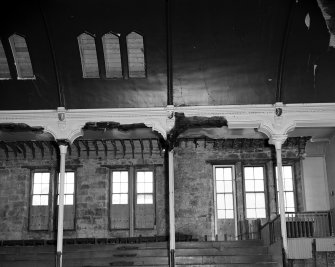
[242,163,269,220]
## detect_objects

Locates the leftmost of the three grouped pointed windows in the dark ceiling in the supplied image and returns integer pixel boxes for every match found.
[78,33,99,78]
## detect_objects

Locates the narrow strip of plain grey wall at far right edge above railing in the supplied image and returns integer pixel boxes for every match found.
[326,136,335,209]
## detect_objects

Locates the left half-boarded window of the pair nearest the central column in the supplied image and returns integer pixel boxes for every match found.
[110,171,130,229]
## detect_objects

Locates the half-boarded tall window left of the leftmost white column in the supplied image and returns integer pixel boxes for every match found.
[29,172,50,230]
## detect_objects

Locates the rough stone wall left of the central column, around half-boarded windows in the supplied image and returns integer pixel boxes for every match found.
[0,139,168,240]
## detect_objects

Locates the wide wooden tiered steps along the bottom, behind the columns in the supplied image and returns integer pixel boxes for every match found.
[0,240,280,267]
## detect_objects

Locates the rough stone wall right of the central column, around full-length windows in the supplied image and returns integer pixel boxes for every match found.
[174,139,304,240]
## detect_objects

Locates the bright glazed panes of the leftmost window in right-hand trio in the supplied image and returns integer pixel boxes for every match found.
[215,167,234,219]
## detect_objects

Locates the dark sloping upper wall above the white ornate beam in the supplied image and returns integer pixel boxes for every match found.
[0,0,335,110]
